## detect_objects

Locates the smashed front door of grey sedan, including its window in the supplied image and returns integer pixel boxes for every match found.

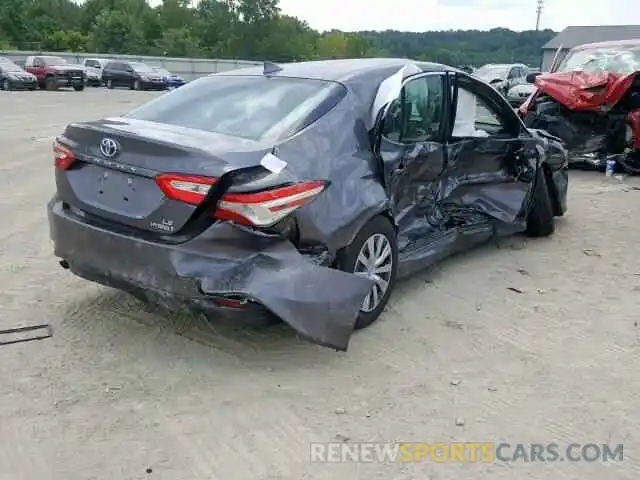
[441,74,541,223]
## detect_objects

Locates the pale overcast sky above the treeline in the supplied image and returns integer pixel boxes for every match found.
[280,0,640,32]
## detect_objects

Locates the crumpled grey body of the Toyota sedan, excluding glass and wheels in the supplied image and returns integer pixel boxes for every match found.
[48,59,567,350]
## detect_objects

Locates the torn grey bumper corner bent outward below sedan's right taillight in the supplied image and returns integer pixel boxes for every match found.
[170,224,373,351]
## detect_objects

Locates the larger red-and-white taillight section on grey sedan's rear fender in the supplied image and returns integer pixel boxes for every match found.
[215,181,327,227]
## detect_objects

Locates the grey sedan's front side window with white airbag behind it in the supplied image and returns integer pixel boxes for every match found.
[452,87,506,138]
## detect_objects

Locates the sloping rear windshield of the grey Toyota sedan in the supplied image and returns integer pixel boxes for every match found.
[126,75,345,140]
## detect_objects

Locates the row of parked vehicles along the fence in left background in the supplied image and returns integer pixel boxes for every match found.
[0,55,186,92]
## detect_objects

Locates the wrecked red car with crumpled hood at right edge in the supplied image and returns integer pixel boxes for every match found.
[518,39,640,174]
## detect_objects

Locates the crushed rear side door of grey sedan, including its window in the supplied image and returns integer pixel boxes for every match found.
[378,73,448,251]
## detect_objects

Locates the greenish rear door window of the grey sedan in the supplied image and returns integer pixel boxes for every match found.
[382,74,443,143]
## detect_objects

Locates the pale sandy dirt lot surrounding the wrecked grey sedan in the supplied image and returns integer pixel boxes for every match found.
[0,89,640,480]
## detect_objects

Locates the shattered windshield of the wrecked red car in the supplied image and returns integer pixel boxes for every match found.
[558,46,640,74]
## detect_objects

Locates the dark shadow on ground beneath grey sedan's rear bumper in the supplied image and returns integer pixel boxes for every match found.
[63,287,348,368]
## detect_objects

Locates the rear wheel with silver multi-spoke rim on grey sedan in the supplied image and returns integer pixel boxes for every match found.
[336,215,398,330]
